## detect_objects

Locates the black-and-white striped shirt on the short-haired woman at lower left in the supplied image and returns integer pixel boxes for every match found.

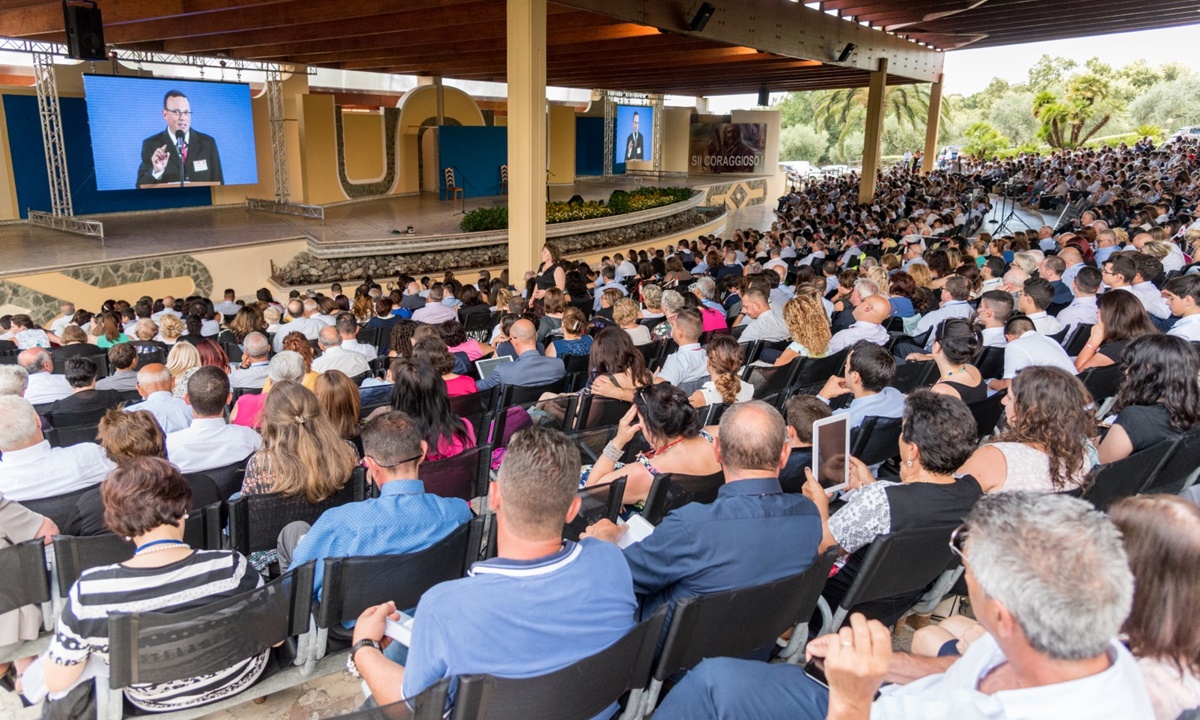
[49,551,269,712]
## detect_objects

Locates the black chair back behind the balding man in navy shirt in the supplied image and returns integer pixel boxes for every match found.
[653,547,838,680]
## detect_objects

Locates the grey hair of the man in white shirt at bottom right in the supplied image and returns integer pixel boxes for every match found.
[966,492,1133,660]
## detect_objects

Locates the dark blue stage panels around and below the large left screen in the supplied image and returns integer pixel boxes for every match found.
[4,95,212,217]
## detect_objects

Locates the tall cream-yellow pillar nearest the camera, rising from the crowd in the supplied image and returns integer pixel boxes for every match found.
[508,0,546,287]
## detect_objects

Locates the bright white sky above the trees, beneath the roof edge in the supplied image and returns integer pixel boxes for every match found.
[709,22,1200,113]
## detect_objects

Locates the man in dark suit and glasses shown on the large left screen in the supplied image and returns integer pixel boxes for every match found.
[138,90,224,187]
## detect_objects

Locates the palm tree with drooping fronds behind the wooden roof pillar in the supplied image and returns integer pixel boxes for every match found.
[812,85,950,157]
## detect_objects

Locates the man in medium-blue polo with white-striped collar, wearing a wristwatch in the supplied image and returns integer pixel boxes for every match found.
[348,427,637,716]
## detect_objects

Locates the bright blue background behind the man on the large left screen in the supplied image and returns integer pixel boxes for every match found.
[83,74,258,192]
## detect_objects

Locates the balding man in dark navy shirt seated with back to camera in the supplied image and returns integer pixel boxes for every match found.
[587,401,821,618]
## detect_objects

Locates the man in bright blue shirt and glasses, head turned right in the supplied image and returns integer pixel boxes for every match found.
[278,412,472,609]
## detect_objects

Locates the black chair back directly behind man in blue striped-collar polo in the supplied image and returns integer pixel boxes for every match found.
[454,606,667,720]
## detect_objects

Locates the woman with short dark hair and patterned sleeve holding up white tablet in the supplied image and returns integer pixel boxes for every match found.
[804,390,983,625]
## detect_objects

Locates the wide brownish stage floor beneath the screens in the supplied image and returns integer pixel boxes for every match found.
[0,176,769,277]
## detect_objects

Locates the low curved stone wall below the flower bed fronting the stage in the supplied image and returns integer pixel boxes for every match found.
[271,208,719,286]
